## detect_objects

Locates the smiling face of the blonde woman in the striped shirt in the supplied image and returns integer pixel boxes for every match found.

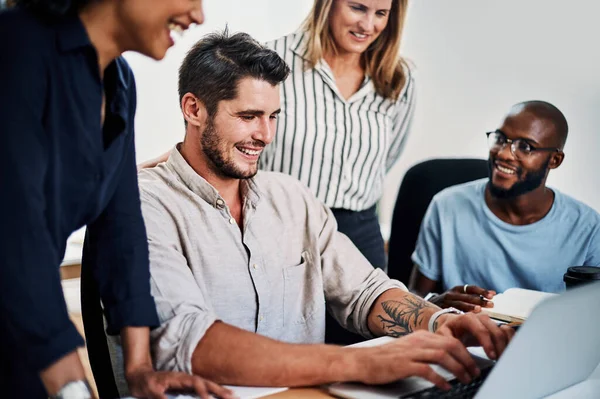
[329,0,392,54]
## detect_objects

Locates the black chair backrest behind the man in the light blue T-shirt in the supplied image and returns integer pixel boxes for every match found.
[388,159,489,286]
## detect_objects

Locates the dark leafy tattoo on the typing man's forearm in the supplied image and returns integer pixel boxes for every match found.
[377,295,434,337]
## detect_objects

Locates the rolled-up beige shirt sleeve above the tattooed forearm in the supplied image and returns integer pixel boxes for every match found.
[313,198,407,338]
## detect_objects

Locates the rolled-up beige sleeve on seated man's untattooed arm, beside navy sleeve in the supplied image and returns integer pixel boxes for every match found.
[142,190,217,373]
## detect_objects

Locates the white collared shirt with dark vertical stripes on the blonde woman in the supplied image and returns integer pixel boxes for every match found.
[261,32,415,211]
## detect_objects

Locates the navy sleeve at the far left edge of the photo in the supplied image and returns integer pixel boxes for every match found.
[0,25,83,371]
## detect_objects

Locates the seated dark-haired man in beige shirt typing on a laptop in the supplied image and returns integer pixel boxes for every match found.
[139,33,512,388]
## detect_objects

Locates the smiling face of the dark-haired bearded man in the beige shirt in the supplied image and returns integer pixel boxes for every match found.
[200,78,280,179]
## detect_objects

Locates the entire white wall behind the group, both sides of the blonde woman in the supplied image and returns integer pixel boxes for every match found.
[127,0,600,233]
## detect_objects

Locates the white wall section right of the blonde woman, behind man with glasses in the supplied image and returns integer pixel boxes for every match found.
[381,0,600,230]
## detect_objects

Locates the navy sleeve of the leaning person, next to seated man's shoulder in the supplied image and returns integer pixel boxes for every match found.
[83,105,158,335]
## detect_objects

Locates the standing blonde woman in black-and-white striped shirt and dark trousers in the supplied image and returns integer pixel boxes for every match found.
[260,0,415,268]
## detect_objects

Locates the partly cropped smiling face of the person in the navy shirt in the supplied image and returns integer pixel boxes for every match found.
[116,0,204,60]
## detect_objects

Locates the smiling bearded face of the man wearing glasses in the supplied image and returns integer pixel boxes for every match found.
[489,108,562,198]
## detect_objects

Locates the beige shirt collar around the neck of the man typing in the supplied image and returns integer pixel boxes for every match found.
[167,143,261,209]
